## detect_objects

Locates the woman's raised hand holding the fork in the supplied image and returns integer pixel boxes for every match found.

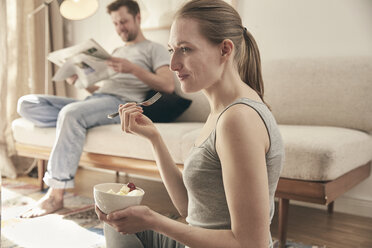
[118,103,158,140]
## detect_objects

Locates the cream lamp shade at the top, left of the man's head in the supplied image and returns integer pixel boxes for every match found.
[59,0,98,20]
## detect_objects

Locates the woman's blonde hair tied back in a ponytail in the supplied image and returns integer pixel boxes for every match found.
[175,0,264,104]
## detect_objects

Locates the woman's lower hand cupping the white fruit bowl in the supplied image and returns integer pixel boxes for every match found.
[96,206,156,234]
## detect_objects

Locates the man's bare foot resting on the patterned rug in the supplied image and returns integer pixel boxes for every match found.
[20,188,64,218]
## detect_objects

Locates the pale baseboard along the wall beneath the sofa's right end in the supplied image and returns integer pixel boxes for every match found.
[280,196,372,218]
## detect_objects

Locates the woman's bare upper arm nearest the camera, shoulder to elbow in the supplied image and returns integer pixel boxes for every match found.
[216,104,270,247]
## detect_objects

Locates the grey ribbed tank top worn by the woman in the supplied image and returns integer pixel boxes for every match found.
[183,98,284,246]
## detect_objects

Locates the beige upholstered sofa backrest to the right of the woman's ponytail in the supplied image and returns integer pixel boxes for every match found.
[263,57,372,132]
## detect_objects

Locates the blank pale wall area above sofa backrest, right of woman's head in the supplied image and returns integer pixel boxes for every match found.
[238,0,372,60]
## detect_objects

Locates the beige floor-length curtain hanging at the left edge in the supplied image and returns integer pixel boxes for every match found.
[0,0,66,178]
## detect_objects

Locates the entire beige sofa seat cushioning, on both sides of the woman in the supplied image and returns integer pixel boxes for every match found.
[12,118,372,181]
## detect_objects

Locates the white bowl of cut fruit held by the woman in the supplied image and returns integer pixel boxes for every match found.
[93,183,145,214]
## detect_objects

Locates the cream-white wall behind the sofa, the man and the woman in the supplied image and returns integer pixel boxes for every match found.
[67,0,372,217]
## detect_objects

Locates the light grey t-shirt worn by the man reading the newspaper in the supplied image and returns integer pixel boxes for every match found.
[97,40,170,102]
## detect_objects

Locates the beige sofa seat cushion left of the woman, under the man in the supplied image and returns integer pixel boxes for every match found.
[12,118,203,163]
